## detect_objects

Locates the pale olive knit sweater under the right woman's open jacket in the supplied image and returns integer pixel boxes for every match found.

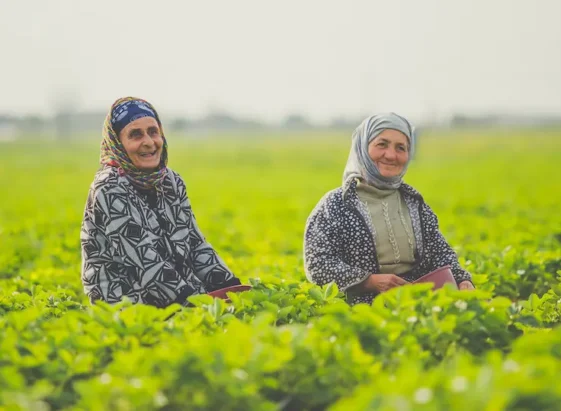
[357,182,415,274]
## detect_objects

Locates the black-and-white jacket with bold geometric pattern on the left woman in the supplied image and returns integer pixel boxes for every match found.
[80,167,240,307]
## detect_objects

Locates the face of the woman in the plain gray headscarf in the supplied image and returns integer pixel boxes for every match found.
[368,129,409,177]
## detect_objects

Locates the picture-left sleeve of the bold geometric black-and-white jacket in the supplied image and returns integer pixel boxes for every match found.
[80,186,200,307]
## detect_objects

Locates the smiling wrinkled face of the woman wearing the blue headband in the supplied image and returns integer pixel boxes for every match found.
[119,117,164,171]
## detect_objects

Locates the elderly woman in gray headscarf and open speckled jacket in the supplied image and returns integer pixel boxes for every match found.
[304,113,473,304]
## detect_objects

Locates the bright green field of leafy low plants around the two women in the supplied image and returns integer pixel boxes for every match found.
[0,130,561,411]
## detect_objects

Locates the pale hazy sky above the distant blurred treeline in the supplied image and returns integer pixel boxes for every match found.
[0,0,561,121]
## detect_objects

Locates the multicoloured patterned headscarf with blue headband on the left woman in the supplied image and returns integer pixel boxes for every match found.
[100,97,168,189]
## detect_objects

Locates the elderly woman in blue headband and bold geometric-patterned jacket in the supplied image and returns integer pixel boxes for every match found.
[81,97,240,307]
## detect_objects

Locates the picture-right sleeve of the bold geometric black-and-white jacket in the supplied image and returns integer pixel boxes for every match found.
[178,178,241,292]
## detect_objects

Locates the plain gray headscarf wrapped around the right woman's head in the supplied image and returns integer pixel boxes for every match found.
[343,113,415,190]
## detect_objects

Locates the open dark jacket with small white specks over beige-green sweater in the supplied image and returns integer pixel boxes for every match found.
[304,179,471,304]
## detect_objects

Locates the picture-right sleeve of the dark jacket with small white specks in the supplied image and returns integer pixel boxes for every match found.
[422,203,471,284]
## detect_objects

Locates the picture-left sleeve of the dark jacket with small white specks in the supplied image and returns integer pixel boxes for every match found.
[304,195,371,292]
